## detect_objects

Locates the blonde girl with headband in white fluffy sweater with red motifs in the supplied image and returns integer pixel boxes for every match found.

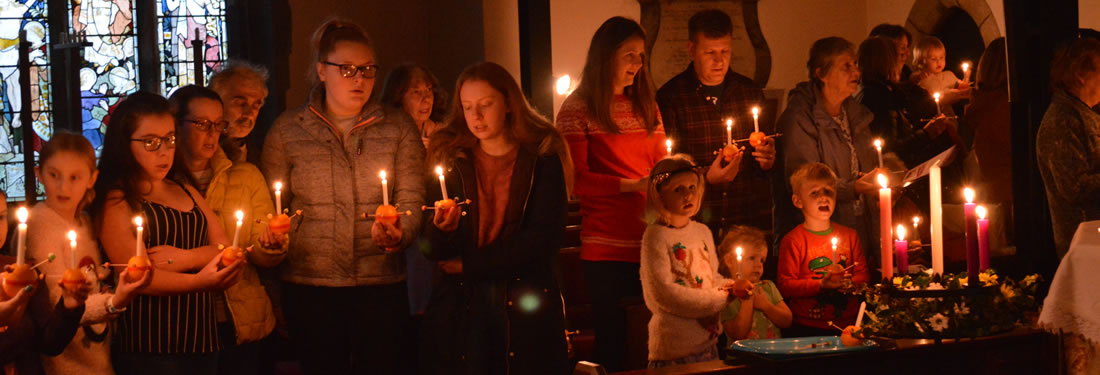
[641,155,733,368]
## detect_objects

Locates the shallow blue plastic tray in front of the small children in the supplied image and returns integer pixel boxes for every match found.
[729,335,879,360]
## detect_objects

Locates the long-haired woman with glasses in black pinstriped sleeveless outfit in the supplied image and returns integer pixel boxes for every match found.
[91,92,244,375]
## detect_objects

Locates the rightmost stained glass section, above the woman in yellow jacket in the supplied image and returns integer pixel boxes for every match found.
[156,0,228,96]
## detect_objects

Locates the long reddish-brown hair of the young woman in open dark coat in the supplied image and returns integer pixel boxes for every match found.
[428,63,573,188]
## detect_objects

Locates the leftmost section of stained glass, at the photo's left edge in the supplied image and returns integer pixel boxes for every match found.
[0,0,52,200]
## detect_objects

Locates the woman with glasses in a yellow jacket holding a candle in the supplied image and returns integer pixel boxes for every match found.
[168,85,287,374]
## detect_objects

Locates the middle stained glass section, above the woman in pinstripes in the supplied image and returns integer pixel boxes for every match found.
[68,0,138,152]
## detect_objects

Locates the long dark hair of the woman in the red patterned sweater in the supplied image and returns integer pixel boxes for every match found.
[576,16,658,134]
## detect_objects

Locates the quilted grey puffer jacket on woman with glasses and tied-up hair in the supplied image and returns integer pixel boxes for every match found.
[261,87,425,287]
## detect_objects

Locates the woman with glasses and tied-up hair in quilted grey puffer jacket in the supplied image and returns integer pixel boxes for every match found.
[261,20,425,374]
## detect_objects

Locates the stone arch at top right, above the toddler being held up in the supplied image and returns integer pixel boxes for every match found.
[905,0,1002,45]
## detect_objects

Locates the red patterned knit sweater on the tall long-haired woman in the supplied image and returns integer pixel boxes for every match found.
[557,93,666,263]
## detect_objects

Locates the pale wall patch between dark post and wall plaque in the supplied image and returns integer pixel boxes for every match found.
[550,0,641,114]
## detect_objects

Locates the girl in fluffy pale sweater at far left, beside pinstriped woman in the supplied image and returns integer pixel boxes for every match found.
[26,132,152,375]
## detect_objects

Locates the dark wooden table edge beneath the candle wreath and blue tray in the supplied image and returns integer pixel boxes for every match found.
[623,328,1058,375]
